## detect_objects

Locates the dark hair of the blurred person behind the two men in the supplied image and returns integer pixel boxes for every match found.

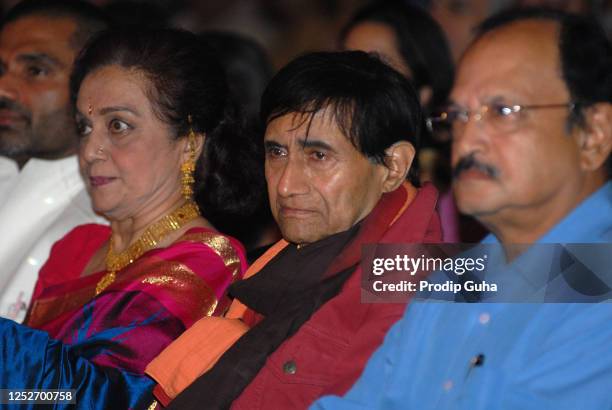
[340,1,454,111]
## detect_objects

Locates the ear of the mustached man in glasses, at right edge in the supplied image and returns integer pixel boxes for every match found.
[579,103,612,171]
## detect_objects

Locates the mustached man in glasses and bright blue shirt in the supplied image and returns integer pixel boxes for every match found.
[313,10,612,410]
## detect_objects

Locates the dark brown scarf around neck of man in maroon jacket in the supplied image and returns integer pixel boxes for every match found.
[168,225,359,409]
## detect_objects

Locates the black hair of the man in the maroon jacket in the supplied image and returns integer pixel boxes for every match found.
[260,51,422,184]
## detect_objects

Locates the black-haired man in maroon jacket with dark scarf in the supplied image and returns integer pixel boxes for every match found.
[147,51,441,410]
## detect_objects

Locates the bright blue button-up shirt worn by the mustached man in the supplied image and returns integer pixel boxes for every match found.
[312,182,612,410]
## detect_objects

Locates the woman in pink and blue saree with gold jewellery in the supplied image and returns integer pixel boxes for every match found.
[0,30,263,409]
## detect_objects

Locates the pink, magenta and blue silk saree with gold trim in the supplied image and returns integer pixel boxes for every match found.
[0,225,246,408]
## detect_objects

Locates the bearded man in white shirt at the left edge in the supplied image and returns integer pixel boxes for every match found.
[0,0,107,321]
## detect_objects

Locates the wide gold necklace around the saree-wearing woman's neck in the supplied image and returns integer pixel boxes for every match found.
[96,201,200,295]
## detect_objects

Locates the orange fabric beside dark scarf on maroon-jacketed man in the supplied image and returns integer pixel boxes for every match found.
[145,240,288,405]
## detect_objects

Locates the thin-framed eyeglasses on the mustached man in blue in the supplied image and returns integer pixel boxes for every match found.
[426,102,577,141]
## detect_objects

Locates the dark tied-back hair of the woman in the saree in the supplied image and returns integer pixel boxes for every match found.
[70,29,265,229]
